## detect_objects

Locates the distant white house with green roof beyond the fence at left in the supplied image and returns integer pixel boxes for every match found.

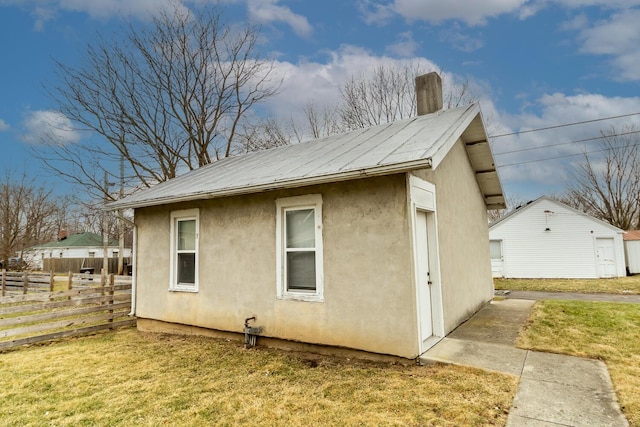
[24,233,131,272]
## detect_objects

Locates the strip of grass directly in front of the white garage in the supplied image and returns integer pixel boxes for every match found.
[493,275,640,294]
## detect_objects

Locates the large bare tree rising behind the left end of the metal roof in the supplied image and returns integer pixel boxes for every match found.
[39,6,276,200]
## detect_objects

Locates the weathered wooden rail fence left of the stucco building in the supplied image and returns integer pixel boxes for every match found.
[0,271,136,350]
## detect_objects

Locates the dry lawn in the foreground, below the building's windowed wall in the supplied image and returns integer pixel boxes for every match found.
[0,329,517,426]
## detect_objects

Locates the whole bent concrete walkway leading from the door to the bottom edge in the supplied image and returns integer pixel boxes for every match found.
[421,298,628,427]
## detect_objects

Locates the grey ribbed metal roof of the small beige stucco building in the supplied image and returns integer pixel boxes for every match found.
[107,103,505,209]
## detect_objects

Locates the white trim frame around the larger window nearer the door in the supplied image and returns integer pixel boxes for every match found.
[276,194,324,302]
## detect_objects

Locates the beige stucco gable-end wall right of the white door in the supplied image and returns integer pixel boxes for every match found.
[414,140,493,333]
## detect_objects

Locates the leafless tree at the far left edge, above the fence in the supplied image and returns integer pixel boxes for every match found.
[0,172,58,266]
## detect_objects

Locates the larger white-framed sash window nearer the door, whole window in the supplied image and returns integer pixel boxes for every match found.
[276,194,323,301]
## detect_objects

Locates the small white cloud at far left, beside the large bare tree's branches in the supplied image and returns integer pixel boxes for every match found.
[22,110,80,145]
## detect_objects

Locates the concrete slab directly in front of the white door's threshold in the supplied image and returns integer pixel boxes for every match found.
[420,338,527,376]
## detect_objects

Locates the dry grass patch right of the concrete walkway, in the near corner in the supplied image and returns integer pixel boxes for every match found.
[518,300,640,426]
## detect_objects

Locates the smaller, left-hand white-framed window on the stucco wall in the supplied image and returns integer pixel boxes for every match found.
[169,209,199,292]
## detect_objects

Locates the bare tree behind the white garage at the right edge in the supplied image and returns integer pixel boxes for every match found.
[561,125,640,230]
